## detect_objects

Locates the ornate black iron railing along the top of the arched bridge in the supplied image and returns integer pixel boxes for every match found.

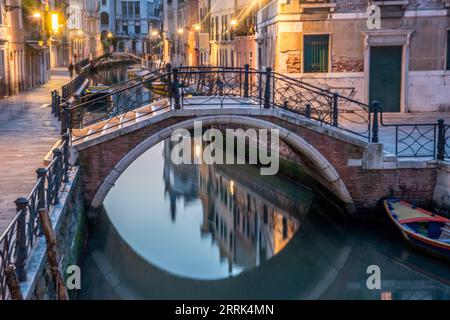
[67,65,371,139]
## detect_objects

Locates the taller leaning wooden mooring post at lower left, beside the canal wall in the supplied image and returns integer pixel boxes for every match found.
[39,209,69,300]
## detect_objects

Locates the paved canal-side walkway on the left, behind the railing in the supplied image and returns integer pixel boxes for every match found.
[0,68,70,234]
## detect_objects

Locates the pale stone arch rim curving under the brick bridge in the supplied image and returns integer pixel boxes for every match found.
[91,115,355,212]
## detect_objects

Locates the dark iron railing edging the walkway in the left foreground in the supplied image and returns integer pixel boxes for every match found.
[0,133,70,300]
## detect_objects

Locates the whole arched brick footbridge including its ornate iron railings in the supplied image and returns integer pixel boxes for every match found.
[67,66,438,213]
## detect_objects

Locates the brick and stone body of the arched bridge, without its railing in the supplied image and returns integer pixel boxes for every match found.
[73,107,439,212]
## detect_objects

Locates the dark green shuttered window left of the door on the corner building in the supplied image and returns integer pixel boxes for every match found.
[303,35,330,72]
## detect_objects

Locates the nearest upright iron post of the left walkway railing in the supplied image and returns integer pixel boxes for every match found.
[14,198,28,281]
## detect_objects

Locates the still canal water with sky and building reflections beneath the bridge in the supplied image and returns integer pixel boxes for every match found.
[80,65,450,300]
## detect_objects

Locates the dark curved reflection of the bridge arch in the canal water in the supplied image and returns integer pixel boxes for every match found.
[80,208,353,300]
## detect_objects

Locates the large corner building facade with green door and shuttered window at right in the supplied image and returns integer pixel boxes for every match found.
[257,0,450,112]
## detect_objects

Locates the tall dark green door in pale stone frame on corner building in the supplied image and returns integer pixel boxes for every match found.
[369,46,402,112]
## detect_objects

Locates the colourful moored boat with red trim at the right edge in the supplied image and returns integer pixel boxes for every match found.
[384,199,450,261]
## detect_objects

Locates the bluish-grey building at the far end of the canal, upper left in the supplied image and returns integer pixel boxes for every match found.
[100,0,161,55]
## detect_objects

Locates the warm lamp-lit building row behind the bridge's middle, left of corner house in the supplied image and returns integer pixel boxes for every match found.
[164,0,264,68]
